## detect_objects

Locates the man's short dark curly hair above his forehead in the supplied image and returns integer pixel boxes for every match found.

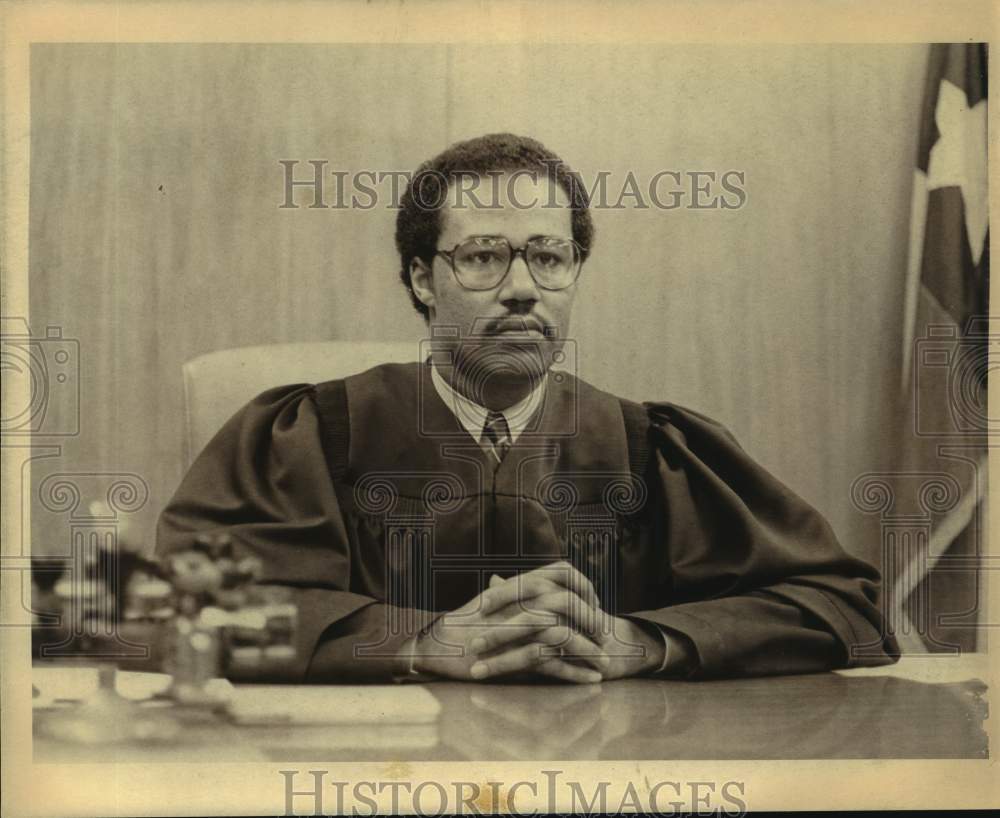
[396,133,594,321]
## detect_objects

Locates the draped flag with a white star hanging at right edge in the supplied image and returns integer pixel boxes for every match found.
[883,44,1000,652]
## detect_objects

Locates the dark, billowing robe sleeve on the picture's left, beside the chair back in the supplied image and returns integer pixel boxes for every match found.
[156,385,432,681]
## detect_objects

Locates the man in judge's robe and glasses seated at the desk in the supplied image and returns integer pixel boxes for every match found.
[158,134,894,683]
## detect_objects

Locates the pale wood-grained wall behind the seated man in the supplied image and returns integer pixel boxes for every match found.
[30,44,927,559]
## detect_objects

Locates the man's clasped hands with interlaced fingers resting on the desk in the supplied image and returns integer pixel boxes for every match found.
[414,562,665,684]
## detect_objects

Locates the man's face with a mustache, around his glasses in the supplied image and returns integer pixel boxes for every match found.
[411,173,576,388]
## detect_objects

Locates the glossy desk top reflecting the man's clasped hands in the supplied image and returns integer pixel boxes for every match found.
[34,656,988,763]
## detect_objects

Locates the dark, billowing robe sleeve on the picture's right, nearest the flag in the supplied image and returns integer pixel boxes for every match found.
[630,403,898,678]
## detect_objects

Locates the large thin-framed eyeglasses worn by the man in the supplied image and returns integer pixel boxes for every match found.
[435,236,583,290]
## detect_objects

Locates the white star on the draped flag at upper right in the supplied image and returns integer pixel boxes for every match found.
[927,75,989,264]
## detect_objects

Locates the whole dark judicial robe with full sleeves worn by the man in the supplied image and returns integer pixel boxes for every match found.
[157,363,895,682]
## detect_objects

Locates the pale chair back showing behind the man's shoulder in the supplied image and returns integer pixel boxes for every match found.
[182,341,420,469]
